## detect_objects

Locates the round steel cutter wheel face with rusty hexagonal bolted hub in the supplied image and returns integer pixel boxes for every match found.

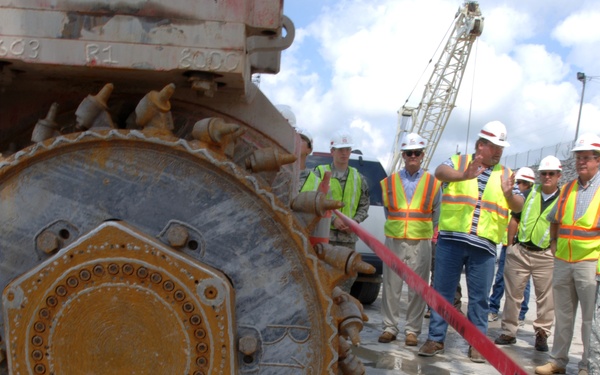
[0,130,337,375]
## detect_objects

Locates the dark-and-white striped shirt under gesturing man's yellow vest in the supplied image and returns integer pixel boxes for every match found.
[439,155,523,256]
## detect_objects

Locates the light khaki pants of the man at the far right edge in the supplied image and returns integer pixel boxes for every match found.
[550,259,597,369]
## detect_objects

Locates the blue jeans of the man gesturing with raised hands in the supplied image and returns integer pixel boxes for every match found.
[428,238,496,342]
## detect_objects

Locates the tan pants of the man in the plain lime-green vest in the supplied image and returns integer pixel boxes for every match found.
[502,244,554,337]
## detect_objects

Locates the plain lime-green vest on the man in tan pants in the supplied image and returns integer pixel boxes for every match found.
[519,185,556,249]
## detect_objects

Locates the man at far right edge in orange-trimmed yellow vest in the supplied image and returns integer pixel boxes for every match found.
[535,134,600,375]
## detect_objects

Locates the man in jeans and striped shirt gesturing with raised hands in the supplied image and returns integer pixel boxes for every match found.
[419,121,524,363]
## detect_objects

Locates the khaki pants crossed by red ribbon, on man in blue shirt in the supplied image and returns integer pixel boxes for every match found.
[381,238,431,336]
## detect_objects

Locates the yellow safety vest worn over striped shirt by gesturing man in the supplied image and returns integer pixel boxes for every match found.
[439,155,511,244]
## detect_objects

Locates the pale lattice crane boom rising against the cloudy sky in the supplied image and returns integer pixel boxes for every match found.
[388,1,484,174]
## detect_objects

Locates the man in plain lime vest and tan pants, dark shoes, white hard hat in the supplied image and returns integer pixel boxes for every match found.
[494,155,562,352]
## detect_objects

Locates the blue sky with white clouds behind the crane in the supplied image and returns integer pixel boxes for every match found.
[260,0,600,168]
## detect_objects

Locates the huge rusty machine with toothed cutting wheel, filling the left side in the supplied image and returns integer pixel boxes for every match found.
[0,0,366,375]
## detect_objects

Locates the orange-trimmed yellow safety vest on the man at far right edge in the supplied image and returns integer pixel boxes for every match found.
[555,180,600,266]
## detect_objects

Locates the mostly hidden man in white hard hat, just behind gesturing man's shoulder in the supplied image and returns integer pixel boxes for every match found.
[488,167,535,327]
